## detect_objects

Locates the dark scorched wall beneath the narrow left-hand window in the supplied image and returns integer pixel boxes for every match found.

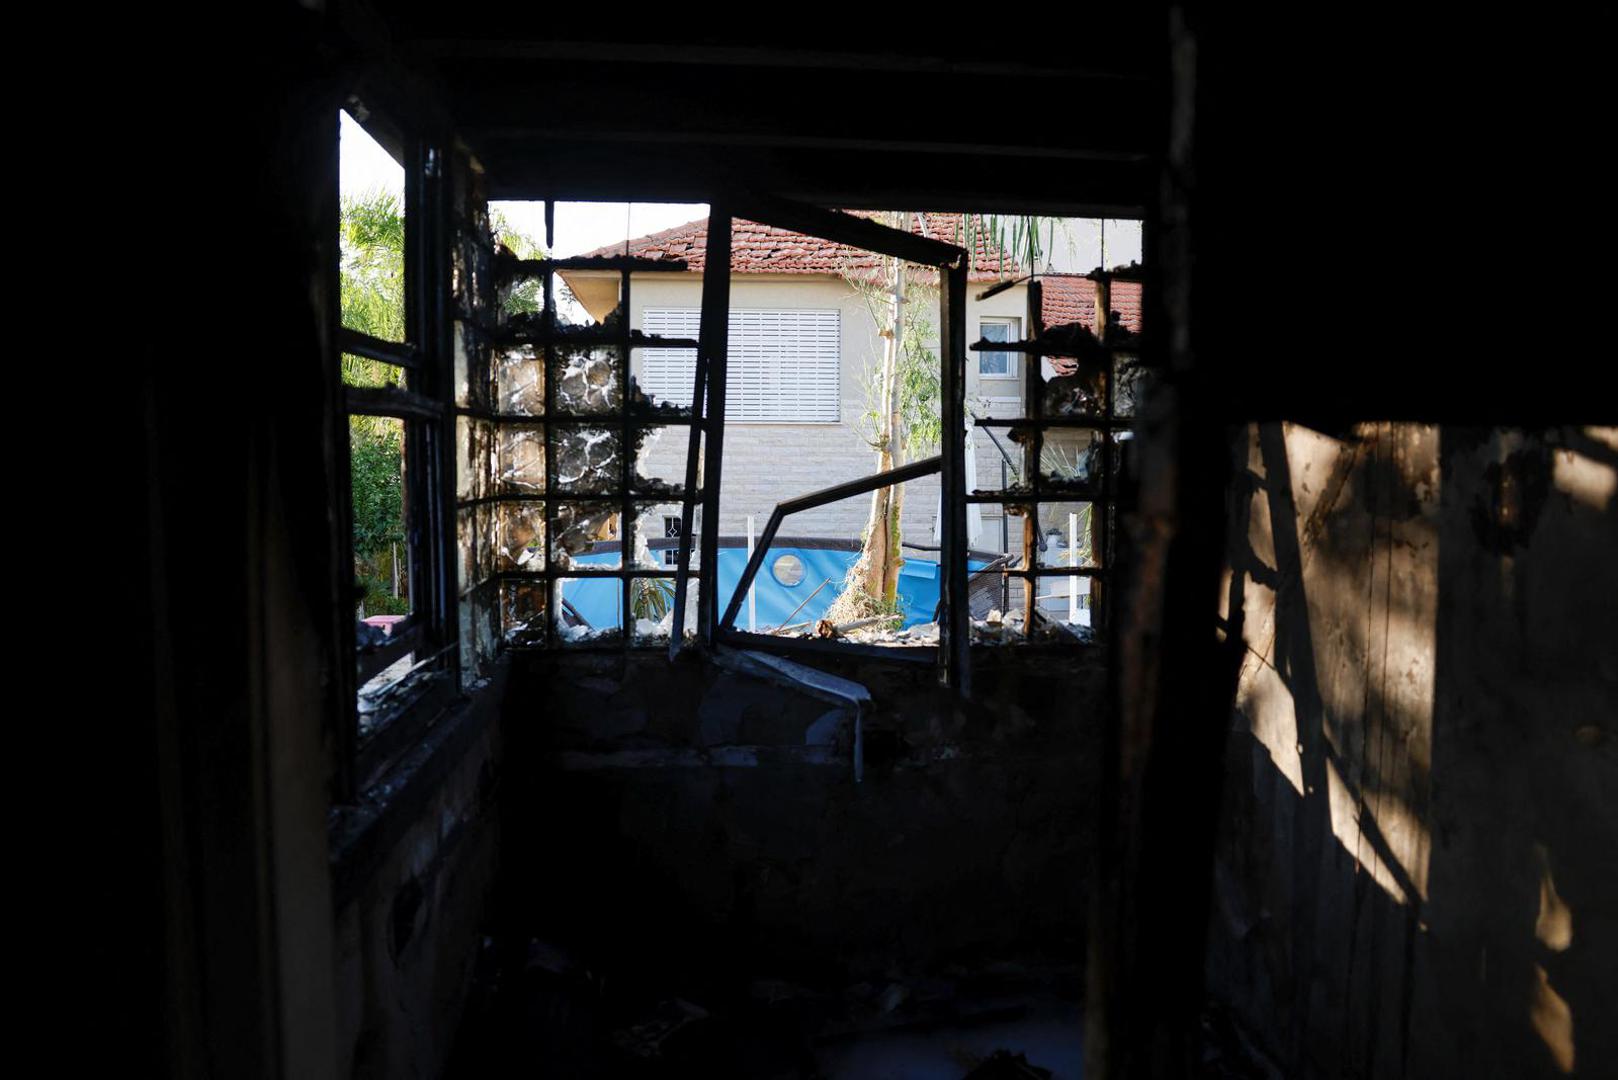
[335,709,502,1077]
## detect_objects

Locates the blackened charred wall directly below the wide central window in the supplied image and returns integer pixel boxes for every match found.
[505,649,1103,981]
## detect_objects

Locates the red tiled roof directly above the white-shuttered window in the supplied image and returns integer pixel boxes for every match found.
[584,214,1019,282]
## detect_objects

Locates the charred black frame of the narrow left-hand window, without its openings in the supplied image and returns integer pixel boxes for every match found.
[332,99,458,800]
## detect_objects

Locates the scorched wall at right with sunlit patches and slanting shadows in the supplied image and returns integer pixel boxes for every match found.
[1207,424,1618,1077]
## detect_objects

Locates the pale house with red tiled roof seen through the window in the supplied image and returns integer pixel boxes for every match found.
[561,214,1139,566]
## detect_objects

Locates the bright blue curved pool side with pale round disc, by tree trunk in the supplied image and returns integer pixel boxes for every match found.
[561,541,984,630]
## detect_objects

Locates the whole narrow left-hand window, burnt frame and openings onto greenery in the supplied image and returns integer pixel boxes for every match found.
[333,104,455,795]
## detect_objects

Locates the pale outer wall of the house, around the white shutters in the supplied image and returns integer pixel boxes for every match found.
[601,274,1027,555]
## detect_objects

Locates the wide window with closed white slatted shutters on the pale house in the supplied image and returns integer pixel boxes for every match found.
[639,308,843,424]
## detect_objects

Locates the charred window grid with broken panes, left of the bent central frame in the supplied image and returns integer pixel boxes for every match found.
[455,204,708,654]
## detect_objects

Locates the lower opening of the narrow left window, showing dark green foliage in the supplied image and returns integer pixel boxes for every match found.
[348,416,411,619]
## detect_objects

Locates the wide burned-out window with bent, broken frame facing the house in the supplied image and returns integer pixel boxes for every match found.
[456,199,1139,687]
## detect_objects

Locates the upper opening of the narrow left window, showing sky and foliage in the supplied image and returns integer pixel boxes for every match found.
[338,110,405,342]
